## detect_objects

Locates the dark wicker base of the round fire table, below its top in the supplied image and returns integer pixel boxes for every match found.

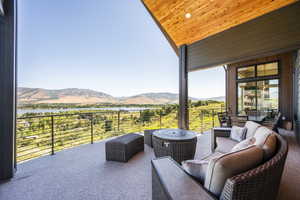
[152,135,197,163]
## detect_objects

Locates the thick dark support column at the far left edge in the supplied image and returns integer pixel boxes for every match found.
[0,0,16,180]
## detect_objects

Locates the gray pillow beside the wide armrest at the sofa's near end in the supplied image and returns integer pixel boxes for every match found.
[181,160,208,183]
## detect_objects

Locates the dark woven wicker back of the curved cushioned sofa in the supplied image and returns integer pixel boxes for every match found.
[220,135,288,200]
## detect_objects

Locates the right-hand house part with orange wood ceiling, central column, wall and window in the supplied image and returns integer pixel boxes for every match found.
[143,0,300,138]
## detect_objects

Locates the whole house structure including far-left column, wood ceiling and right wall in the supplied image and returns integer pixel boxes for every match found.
[0,0,300,186]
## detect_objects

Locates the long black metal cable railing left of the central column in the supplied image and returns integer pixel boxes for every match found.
[17,110,168,162]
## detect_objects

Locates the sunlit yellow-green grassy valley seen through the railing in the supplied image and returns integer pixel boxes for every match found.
[17,102,224,162]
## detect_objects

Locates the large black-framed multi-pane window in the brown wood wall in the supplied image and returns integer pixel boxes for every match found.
[237,62,279,115]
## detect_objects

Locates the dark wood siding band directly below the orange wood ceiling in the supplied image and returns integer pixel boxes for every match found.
[188,2,300,71]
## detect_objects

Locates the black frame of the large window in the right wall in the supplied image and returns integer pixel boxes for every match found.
[235,60,281,116]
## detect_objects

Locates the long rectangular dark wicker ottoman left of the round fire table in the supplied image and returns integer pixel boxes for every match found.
[105,133,144,162]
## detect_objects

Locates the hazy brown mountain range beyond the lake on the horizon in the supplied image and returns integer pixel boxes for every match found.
[18,87,224,104]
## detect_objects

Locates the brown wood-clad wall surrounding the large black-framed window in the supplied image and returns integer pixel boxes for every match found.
[226,52,294,120]
